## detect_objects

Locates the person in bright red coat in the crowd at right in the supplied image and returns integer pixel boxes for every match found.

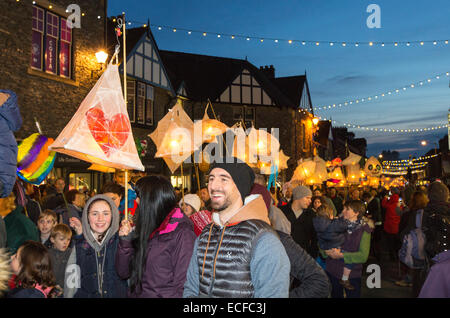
[381,188,401,261]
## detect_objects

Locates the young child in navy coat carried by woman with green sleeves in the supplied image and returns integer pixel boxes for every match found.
[313,204,361,290]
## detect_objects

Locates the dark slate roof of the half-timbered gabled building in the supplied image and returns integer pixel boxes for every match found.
[107,17,309,109]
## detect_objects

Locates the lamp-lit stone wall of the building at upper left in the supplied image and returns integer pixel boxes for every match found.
[0,0,105,139]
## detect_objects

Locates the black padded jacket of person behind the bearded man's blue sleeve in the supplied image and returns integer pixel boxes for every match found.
[277,231,331,298]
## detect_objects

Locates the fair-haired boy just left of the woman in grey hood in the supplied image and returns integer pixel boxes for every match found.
[49,224,72,288]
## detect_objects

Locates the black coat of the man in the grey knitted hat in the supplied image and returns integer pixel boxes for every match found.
[280,202,318,259]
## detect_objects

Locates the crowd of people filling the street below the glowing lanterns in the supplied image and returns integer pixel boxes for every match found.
[0,158,450,298]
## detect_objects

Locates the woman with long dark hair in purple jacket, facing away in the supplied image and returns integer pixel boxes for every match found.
[116,176,196,298]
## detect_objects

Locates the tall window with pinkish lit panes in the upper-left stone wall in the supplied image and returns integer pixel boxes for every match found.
[31,6,72,78]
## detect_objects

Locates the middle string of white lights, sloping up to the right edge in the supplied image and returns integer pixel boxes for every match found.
[314,72,450,110]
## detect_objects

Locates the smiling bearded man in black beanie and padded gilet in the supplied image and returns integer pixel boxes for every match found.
[183,158,290,298]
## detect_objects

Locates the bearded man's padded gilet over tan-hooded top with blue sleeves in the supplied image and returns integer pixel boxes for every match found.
[183,195,290,298]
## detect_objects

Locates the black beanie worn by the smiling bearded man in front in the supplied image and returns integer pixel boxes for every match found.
[209,157,255,202]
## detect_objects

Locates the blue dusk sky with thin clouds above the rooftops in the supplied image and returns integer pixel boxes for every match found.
[108,0,450,158]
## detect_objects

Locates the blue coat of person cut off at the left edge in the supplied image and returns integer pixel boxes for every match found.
[0,89,22,198]
